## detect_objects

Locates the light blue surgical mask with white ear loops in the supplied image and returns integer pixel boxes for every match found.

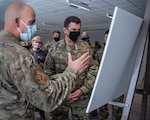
[18,20,37,41]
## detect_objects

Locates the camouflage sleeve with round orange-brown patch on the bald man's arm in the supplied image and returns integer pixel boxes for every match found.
[8,54,77,112]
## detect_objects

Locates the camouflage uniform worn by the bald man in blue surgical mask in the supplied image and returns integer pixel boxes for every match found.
[0,31,77,120]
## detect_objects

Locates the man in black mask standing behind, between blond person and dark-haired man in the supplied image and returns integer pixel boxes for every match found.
[44,30,61,51]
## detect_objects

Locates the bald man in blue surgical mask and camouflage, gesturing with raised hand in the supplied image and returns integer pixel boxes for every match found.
[0,2,90,120]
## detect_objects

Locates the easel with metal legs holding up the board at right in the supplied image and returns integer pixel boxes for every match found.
[109,0,150,120]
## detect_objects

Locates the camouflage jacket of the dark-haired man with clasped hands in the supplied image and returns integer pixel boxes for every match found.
[44,40,98,98]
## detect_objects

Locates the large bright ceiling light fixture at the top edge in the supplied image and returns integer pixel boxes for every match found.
[66,0,91,11]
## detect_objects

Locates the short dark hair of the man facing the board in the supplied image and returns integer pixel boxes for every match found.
[64,16,81,28]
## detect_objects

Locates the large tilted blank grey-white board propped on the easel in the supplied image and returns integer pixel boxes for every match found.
[86,7,142,113]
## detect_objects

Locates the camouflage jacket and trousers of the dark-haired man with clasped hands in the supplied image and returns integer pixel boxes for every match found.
[44,40,98,120]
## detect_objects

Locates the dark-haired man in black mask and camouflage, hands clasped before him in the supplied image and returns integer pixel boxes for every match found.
[44,16,98,120]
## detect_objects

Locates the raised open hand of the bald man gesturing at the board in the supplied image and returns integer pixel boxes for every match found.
[68,53,90,74]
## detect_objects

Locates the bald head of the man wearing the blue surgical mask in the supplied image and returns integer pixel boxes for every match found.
[4,2,35,39]
